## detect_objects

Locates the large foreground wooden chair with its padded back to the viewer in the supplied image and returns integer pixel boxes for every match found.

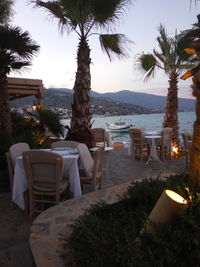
[23,150,69,218]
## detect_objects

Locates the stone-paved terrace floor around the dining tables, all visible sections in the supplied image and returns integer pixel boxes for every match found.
[0,149,188,267]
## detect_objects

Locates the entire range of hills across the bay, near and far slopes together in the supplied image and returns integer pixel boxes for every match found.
[12,88,195,115]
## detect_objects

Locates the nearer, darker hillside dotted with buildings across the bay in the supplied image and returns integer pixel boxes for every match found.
[11,89,152,115]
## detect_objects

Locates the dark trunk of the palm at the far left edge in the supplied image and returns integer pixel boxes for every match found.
[0,75,12,137]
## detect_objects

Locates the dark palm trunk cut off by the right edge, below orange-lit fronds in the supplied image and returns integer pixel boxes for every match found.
[189,74,200,184]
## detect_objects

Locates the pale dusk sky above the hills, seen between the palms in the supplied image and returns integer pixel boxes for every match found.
[10,0,200,98]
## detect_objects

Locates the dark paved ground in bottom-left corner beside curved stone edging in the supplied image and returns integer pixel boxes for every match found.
[0,193,35,267]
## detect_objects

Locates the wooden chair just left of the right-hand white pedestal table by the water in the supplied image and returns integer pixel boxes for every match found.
[129,128,149,161]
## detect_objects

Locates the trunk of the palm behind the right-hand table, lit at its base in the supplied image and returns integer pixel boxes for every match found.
[163,71,179,146]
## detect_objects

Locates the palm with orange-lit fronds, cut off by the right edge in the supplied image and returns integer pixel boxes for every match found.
[181,14,200,184]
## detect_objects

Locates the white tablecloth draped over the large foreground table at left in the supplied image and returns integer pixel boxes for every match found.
[12,149,82,209]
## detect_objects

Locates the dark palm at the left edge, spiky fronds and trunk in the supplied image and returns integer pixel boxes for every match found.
[0,24,39,137]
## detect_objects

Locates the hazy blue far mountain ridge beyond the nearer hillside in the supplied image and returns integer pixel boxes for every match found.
[47,88,195,112]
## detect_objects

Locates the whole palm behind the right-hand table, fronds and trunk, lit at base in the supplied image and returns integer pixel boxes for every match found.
[138,25,191,145]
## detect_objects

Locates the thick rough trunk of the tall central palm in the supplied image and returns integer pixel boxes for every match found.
[70,37,92,146]
